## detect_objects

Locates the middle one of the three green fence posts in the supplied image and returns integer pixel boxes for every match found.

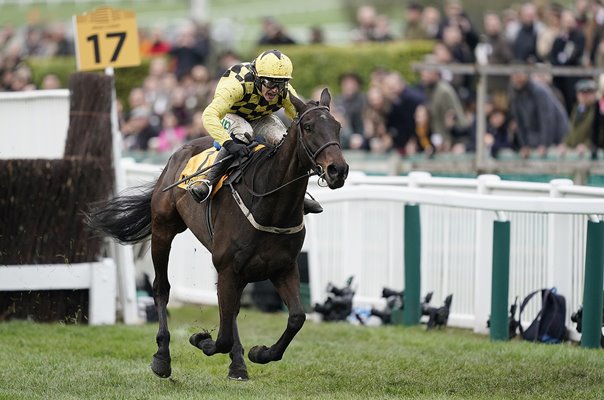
[490,221,510,340]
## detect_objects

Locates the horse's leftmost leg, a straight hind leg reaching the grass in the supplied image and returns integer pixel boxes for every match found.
[151,226,176,378]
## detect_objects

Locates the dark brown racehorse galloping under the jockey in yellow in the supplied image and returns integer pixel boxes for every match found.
[88,89,348,380]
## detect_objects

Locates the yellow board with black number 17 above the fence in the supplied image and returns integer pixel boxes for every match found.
[73,7,141,71]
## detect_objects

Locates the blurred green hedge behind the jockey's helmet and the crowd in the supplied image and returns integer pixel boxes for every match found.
[28,41,433,107]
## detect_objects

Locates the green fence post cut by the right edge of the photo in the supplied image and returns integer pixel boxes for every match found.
[581,221,604,348]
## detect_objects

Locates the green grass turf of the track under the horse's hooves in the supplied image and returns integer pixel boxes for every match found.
[0,306,604,400]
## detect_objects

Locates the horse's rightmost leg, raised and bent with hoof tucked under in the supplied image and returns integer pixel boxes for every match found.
[248,265,306,364]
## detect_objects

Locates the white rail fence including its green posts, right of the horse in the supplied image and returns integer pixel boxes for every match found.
[308,173,604,347]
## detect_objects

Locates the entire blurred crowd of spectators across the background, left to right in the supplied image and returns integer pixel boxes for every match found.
[0,0,604,158]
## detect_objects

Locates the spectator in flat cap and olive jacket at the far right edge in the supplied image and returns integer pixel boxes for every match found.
[560,79,598,158]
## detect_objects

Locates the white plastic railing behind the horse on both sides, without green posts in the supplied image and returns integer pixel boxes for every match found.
[126,165,604,332]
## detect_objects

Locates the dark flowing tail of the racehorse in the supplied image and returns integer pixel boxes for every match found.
[86,184,155,243]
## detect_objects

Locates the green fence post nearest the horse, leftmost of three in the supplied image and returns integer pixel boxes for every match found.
[403,204,421,325]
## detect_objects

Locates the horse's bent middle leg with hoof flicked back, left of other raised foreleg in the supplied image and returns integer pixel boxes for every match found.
[189,269,243,356]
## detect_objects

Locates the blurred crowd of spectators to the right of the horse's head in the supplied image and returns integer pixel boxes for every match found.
[336,0,604,158]
